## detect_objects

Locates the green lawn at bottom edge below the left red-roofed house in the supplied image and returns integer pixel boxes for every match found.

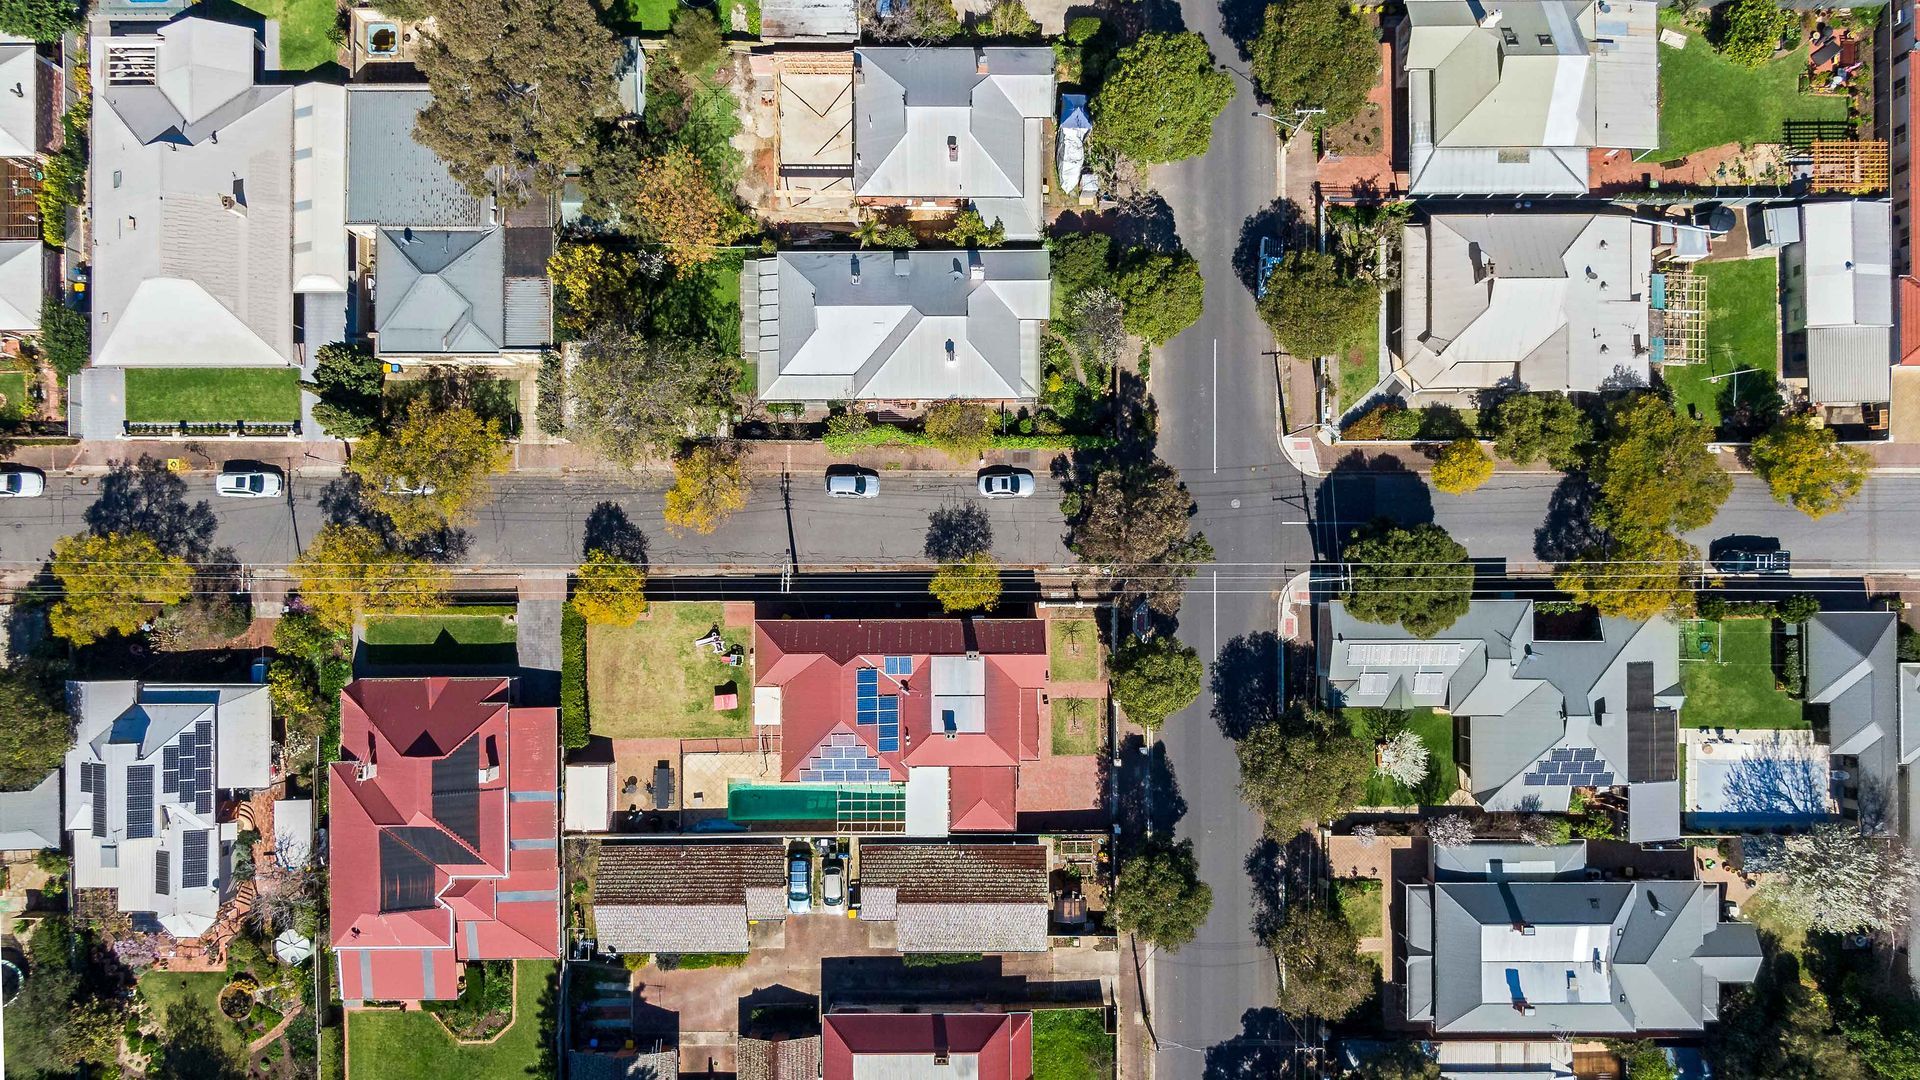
[348,961,557,1080]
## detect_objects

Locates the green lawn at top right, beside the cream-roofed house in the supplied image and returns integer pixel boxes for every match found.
[1647,12,1847,161]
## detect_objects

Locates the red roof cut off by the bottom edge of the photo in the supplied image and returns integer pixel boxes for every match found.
[820,1013,1033,1080]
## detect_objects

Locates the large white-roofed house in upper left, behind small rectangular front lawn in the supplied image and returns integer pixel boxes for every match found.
[83,17,348,368]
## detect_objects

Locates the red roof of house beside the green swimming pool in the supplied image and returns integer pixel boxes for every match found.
[755,619,1046,832]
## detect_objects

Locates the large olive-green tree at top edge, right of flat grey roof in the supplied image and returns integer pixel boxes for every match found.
[415,0,620,204]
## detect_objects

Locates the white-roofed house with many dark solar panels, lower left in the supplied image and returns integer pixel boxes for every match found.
[65,682,273,938]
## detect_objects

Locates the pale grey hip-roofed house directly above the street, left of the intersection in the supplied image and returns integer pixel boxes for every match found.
[741,250,1052,402]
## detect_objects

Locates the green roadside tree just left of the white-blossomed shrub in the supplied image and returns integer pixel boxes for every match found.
[1235,713,1373,826]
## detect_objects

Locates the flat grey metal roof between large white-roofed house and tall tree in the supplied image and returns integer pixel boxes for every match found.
[348,86,486,229]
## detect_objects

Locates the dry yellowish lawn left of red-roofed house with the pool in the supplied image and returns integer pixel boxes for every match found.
[588,603,753,738]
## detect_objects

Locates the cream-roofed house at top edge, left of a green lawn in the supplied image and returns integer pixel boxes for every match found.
[1396,0,1661,196]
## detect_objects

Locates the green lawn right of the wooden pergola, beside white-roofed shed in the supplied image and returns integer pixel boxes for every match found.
[1661,258,1780,427]
